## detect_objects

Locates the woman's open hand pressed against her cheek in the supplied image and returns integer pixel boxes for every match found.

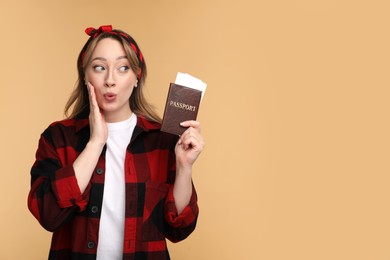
[87,82,108,146]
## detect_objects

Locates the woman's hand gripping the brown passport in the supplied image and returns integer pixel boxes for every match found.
[175,120,205,168]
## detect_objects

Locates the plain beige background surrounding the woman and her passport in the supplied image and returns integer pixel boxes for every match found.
[0,0,390,260]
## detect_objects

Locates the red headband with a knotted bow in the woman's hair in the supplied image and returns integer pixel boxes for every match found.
[82,25,144,79]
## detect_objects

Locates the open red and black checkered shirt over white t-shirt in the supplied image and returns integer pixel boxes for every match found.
[28,116,198,260]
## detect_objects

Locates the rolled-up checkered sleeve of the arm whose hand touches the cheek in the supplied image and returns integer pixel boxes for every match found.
[28,127,90,231]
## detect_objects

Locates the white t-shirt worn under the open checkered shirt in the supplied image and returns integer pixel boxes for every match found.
[97,113,137,260]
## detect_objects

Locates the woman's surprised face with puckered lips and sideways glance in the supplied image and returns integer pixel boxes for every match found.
[85,38,137,122]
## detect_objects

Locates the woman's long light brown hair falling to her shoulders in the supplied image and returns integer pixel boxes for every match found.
[64,30,161,123]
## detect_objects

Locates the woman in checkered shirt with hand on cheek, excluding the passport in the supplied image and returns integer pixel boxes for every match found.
[28,26,204,260]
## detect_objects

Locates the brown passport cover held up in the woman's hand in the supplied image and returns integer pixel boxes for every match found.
[161,83,202,135]
